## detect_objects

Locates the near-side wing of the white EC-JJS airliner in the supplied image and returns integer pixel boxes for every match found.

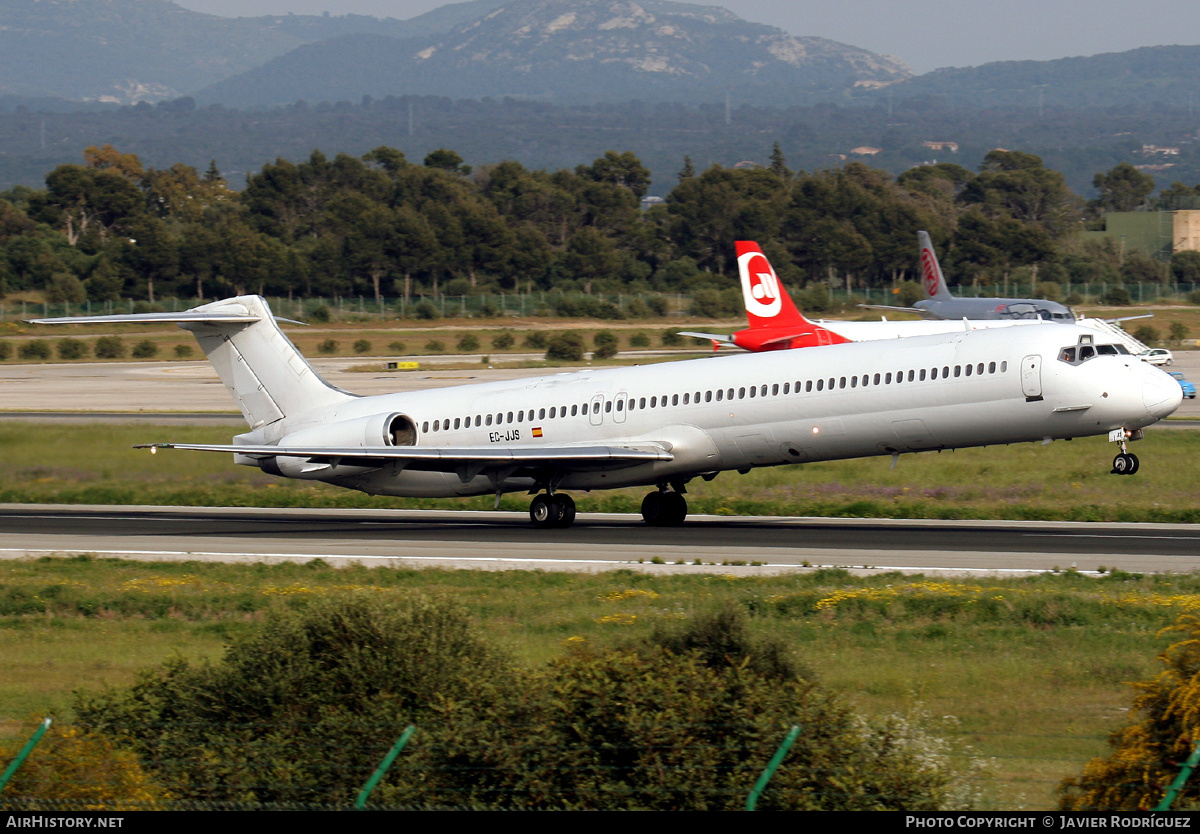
[134,443,674,473]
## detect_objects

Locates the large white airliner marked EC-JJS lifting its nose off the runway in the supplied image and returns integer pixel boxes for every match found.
[32,295,1182,527]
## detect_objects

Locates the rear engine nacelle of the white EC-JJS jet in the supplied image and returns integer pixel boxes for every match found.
[258,413,416,481]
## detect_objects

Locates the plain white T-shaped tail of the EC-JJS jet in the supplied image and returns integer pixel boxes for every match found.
[34,295,355,428]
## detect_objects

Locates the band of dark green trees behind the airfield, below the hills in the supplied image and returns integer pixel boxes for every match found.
[0,145,1196,311]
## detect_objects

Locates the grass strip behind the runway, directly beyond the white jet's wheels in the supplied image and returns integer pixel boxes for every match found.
[0,422,1200,522]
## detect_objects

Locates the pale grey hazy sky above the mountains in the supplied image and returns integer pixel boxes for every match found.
[175,0,1200,72]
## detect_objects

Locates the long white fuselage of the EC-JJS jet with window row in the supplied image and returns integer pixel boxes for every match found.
[238,325,1180,497]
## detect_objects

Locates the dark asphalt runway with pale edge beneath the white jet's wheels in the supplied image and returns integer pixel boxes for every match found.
[0,504,1200,575]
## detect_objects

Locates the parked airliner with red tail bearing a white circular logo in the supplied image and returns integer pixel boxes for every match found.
[679,240,1042,350]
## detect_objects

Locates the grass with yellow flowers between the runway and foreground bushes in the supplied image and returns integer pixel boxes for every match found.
[0,557,1200,810]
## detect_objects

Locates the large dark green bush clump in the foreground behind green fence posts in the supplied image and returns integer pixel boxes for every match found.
[77,595,962,810]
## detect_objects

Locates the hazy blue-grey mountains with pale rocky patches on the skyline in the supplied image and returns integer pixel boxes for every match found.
[0,0,912,107]
